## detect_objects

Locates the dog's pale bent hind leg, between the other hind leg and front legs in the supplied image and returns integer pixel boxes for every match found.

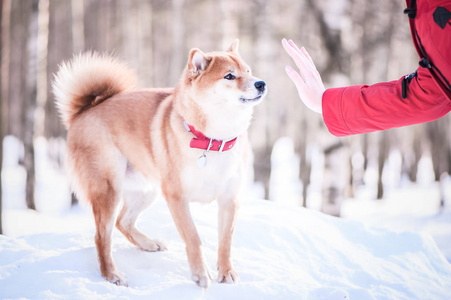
[116,189,167,252]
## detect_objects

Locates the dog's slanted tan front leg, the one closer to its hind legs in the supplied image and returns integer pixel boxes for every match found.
[166,195,211,288]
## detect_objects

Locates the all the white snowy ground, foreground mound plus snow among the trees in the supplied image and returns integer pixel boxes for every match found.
[0,137,451,300]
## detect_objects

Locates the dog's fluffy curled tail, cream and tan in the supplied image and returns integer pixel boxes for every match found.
[52,52,136,128]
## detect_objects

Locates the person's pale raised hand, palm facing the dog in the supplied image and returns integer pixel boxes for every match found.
[282,39,326,114]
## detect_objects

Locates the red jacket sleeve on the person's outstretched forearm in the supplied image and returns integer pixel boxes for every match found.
[322,68,451,136]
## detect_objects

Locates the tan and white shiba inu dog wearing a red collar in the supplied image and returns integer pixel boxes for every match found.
[52,40,267,288]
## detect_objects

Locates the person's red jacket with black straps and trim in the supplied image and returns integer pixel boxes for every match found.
[322,0,451,136]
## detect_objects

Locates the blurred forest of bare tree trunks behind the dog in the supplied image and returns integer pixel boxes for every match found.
[0,0,451,232]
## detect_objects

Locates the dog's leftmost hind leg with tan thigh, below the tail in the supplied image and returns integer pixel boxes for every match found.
[68,141,127,286]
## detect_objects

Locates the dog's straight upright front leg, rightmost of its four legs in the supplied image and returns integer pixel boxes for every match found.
[218,198,239,283]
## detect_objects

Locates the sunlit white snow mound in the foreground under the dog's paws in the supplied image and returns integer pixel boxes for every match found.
[0,200,451,300]
